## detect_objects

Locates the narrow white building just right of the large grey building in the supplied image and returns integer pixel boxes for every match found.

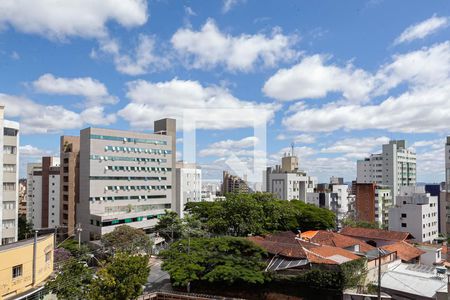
[175,161,202,218]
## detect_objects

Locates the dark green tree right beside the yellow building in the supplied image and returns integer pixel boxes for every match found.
[46,258,93,300]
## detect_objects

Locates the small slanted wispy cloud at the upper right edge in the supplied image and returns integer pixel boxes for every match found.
[394,15,449,44]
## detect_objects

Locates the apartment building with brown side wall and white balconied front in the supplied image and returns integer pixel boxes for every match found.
[354,183,392,227]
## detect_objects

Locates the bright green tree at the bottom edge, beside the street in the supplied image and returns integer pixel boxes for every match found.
[89,252,150,300]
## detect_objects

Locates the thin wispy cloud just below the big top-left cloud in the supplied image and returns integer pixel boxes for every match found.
[91,34,170,76]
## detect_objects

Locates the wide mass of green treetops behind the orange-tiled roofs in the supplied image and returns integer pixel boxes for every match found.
[186,193,335,236]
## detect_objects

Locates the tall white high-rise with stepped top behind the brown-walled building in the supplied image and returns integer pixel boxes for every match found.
[356,140,416,203]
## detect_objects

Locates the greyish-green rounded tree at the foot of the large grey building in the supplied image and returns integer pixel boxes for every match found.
[101,225,152,254]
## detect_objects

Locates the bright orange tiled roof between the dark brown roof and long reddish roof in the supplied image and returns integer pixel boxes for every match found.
[301,230,375,252]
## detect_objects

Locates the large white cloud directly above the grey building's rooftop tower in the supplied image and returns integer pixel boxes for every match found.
[118,79,279,129]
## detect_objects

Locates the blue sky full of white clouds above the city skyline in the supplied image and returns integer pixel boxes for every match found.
[0,0,450,182]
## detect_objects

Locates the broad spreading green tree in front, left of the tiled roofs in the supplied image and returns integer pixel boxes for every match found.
[160,237,267,286]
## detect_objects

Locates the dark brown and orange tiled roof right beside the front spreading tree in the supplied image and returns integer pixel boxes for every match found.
[248,232,360,264]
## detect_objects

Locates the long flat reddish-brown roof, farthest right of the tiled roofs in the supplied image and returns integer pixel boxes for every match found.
[340,227,414,241]
